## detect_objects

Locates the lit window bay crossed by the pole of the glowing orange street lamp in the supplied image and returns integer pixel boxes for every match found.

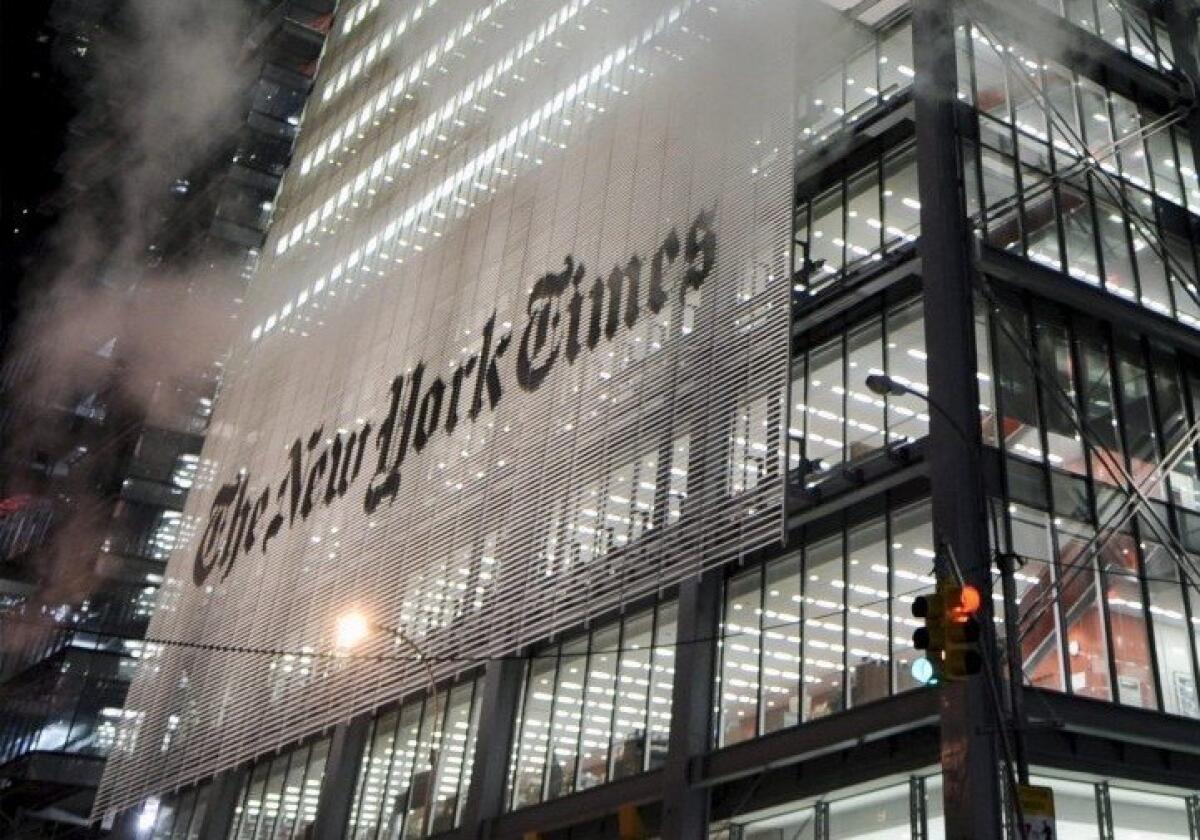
[346,678,482,840]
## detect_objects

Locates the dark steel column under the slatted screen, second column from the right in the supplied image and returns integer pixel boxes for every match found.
[661,571,721,840]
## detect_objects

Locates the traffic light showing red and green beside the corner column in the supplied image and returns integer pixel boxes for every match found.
[912,582,983,685]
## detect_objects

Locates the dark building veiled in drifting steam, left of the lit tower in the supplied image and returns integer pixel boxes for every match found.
[0,0,331,838]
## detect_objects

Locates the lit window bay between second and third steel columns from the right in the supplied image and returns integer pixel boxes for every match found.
[509,601,677,809]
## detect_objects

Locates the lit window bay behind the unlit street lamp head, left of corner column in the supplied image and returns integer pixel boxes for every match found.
[788,299,929,486]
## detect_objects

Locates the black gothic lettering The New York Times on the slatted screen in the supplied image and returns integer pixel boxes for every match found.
[192,211,716,586]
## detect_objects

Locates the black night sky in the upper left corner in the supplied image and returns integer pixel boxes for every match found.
[0,0,70,343]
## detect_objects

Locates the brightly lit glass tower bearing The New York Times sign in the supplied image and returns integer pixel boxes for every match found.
[96,0,1200,839]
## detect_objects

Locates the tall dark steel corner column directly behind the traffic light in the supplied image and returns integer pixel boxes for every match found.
[912,0,1001,840]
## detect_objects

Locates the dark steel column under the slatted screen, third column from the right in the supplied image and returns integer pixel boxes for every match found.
[460,659,526,839]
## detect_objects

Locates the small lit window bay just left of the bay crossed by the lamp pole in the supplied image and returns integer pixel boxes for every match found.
[229,738,329,840]
